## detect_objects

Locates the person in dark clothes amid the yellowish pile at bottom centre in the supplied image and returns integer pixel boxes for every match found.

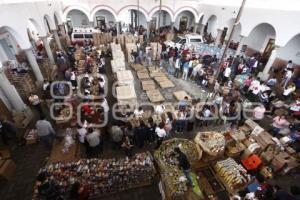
[174,147,194,187]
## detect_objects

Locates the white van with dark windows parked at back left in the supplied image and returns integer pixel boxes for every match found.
[71,28,100,45]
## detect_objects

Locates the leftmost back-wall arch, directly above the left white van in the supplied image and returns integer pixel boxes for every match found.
[67,9,90,28]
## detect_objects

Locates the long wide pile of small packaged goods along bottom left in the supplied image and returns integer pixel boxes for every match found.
[33,153,155,199]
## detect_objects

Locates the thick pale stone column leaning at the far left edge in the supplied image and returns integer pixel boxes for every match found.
[0,66,27,113]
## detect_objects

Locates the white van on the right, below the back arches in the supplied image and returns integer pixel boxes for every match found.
[165,34,203,49]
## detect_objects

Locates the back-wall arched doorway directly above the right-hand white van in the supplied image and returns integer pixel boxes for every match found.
[175,10,195,32]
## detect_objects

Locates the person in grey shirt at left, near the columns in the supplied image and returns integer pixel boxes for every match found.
[35,116,55,149]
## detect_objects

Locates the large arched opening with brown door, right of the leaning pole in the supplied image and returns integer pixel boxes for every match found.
[245,23,276,64]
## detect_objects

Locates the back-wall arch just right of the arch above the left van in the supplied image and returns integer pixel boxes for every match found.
[93,9,116,29]
